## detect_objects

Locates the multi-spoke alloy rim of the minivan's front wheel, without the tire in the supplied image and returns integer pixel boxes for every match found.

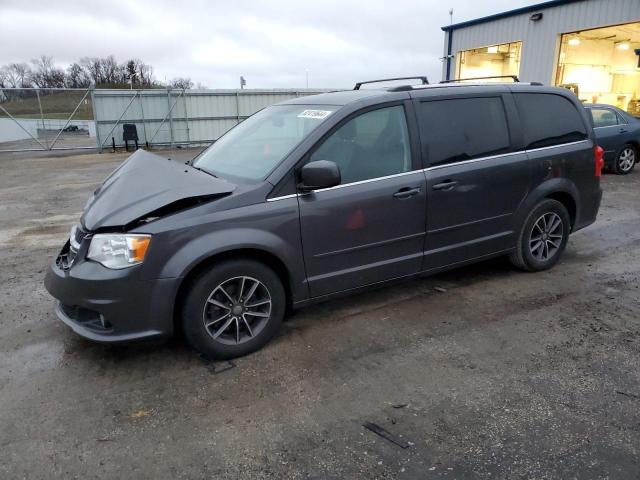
[202,276,272,345]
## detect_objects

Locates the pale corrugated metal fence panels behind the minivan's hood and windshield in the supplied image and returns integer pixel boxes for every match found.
[92,89,327,147]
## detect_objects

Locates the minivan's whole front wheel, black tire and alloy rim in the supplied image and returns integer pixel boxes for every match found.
[182,259,286,360]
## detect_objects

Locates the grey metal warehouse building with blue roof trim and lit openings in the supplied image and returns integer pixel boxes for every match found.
[442,0,640,115]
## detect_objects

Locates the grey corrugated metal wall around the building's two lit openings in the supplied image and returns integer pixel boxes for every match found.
[442,0,640,85]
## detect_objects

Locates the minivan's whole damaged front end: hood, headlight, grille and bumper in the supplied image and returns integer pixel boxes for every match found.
[45,150,236,342]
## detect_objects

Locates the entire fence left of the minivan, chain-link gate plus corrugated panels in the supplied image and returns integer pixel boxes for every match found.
[0,88,326,152]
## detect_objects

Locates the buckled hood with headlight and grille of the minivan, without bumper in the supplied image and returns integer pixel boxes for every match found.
[55,150,235,271]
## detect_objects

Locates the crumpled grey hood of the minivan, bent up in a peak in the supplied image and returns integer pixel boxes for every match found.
[80,150,236,230]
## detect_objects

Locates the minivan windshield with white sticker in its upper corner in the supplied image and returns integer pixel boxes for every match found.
[193,105,338,181]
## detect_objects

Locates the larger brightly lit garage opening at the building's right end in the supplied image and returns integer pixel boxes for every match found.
[555,22,640,115]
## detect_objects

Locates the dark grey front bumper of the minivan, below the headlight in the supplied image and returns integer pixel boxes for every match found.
[44,249,179,343]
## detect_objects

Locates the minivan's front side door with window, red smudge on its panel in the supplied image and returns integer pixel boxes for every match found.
[298,103,426,297]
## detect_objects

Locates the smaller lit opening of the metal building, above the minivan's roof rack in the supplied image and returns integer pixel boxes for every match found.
[456,42,522,81]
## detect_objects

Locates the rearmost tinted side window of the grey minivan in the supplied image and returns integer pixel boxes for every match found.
[513,93,587,149]
